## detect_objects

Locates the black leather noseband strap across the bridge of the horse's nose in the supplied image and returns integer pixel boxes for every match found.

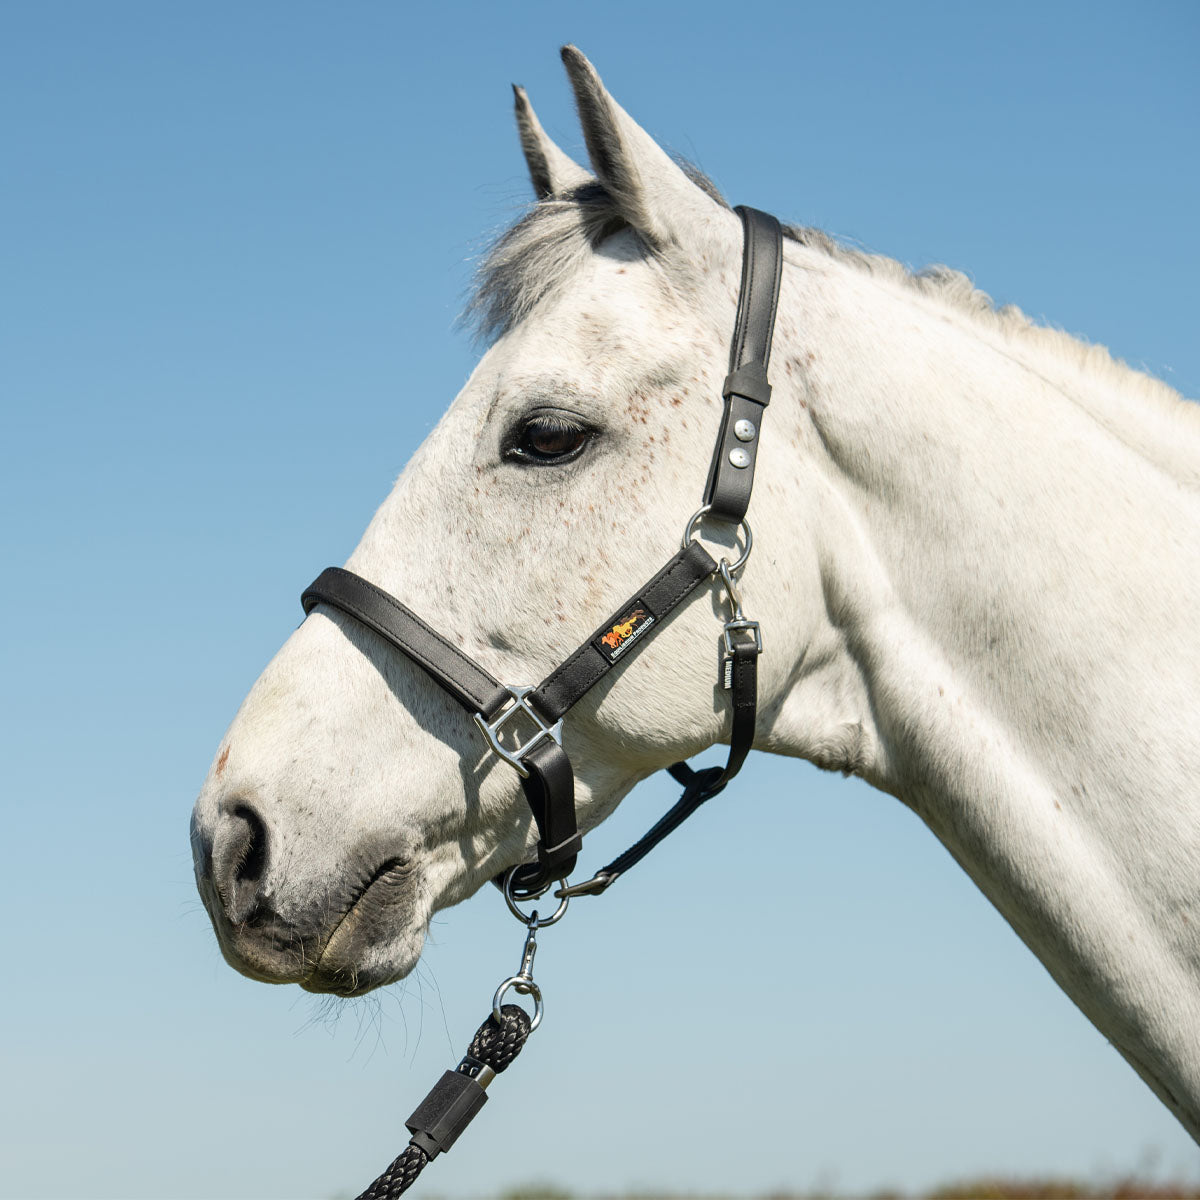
[300,566,509,718]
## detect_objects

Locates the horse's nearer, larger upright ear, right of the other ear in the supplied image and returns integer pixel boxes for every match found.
[562,46,715,250]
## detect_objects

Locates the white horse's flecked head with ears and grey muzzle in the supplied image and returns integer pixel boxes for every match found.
[193,48,816,995]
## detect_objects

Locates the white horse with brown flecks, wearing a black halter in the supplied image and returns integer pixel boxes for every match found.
[193,48,1200,1140]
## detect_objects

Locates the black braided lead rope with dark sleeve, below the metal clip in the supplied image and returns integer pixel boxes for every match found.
[358,1004,533,1200]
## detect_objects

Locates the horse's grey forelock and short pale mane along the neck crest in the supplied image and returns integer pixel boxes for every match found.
[463,160,1200,418]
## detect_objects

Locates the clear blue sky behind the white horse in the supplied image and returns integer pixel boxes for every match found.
[0,0,1200,1200]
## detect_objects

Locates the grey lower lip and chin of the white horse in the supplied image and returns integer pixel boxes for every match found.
[300,858,424,997]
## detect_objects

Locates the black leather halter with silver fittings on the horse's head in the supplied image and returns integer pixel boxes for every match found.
[300,208,782,899]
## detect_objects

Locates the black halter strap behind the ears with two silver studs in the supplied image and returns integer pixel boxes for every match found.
[704,206,784,522]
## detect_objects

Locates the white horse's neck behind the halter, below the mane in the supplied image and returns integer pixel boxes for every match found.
[763,246,1200,1139]
